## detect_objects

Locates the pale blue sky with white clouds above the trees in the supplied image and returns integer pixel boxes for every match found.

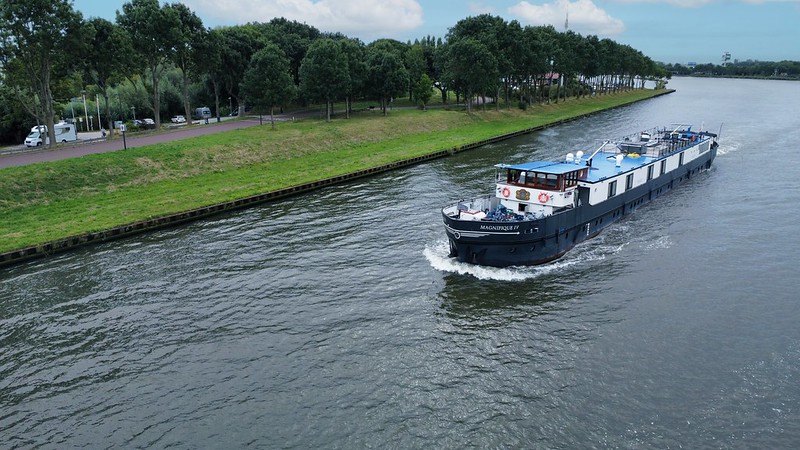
[73,0,800,64]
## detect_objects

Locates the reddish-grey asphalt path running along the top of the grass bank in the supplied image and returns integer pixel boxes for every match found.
[0,117,269,169]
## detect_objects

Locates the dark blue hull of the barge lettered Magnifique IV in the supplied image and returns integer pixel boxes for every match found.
[442,146,717,267]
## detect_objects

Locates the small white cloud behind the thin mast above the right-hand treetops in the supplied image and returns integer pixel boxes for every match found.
[508,0,625,37]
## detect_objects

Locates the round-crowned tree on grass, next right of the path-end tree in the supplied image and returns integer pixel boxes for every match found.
[300,38,350,122]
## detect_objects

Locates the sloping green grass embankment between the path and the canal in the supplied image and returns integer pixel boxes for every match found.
[0,90,664,253]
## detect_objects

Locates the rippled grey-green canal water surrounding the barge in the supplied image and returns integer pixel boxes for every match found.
[0,78,800,449]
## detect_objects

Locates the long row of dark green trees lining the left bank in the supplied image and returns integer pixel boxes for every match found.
[0,0,669,146]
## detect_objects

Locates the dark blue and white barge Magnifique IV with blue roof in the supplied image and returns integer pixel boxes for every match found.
[442,125,718,267]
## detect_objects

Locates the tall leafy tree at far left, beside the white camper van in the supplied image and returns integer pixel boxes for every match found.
[0,0,87,145]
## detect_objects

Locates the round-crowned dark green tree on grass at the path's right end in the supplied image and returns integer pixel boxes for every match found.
[240,44,296,130]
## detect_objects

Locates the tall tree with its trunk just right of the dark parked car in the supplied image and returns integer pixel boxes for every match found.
[117,0,181,128]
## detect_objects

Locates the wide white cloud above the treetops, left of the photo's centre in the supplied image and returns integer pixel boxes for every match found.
[183,0,422,37]
